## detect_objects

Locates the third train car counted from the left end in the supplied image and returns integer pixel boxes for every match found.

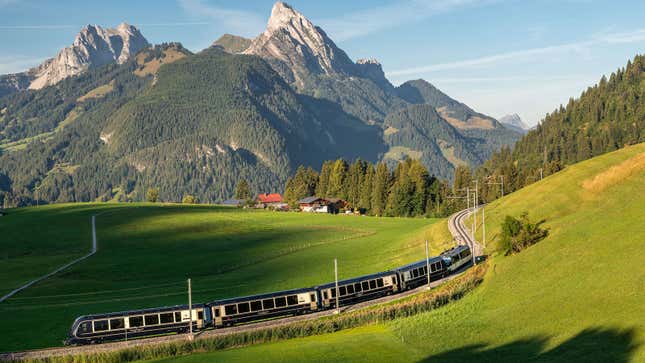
[316,271,399,309]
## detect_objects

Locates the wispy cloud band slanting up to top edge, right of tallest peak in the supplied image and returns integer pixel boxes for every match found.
[316,0,502,41]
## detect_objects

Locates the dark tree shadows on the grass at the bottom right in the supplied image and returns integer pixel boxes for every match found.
[421,327,639,363]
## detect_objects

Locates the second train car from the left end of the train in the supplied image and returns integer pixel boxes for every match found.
[206,288,318,328]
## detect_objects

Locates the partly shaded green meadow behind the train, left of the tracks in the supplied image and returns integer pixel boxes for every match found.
[0,203,449,351]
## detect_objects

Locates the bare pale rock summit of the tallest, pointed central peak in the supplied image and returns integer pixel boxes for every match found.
[244,2,357,86]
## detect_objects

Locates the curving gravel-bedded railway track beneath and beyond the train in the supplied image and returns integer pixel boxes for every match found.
[0,210,482,361]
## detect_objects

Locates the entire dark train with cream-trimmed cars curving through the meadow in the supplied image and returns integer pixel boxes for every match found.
[65,245,472,345]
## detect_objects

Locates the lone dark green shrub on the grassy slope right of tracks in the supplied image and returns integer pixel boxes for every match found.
[501,212,549,256]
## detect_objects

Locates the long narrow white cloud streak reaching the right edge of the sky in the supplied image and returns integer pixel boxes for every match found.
[387,29,645,76]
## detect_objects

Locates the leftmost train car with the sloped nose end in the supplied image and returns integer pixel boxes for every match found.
[65,304,210,345]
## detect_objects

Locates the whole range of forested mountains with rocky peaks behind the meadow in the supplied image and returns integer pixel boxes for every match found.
[0,2,520,208]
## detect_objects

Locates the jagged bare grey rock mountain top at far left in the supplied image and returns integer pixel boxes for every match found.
[0,23,149,96]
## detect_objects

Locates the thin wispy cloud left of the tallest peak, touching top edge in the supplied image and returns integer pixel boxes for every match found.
[178,0,266,36]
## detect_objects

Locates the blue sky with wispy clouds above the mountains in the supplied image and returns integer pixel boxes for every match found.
[0,0,645,124]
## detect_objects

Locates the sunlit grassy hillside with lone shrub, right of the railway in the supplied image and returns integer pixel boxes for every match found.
[156,144,645,362]
